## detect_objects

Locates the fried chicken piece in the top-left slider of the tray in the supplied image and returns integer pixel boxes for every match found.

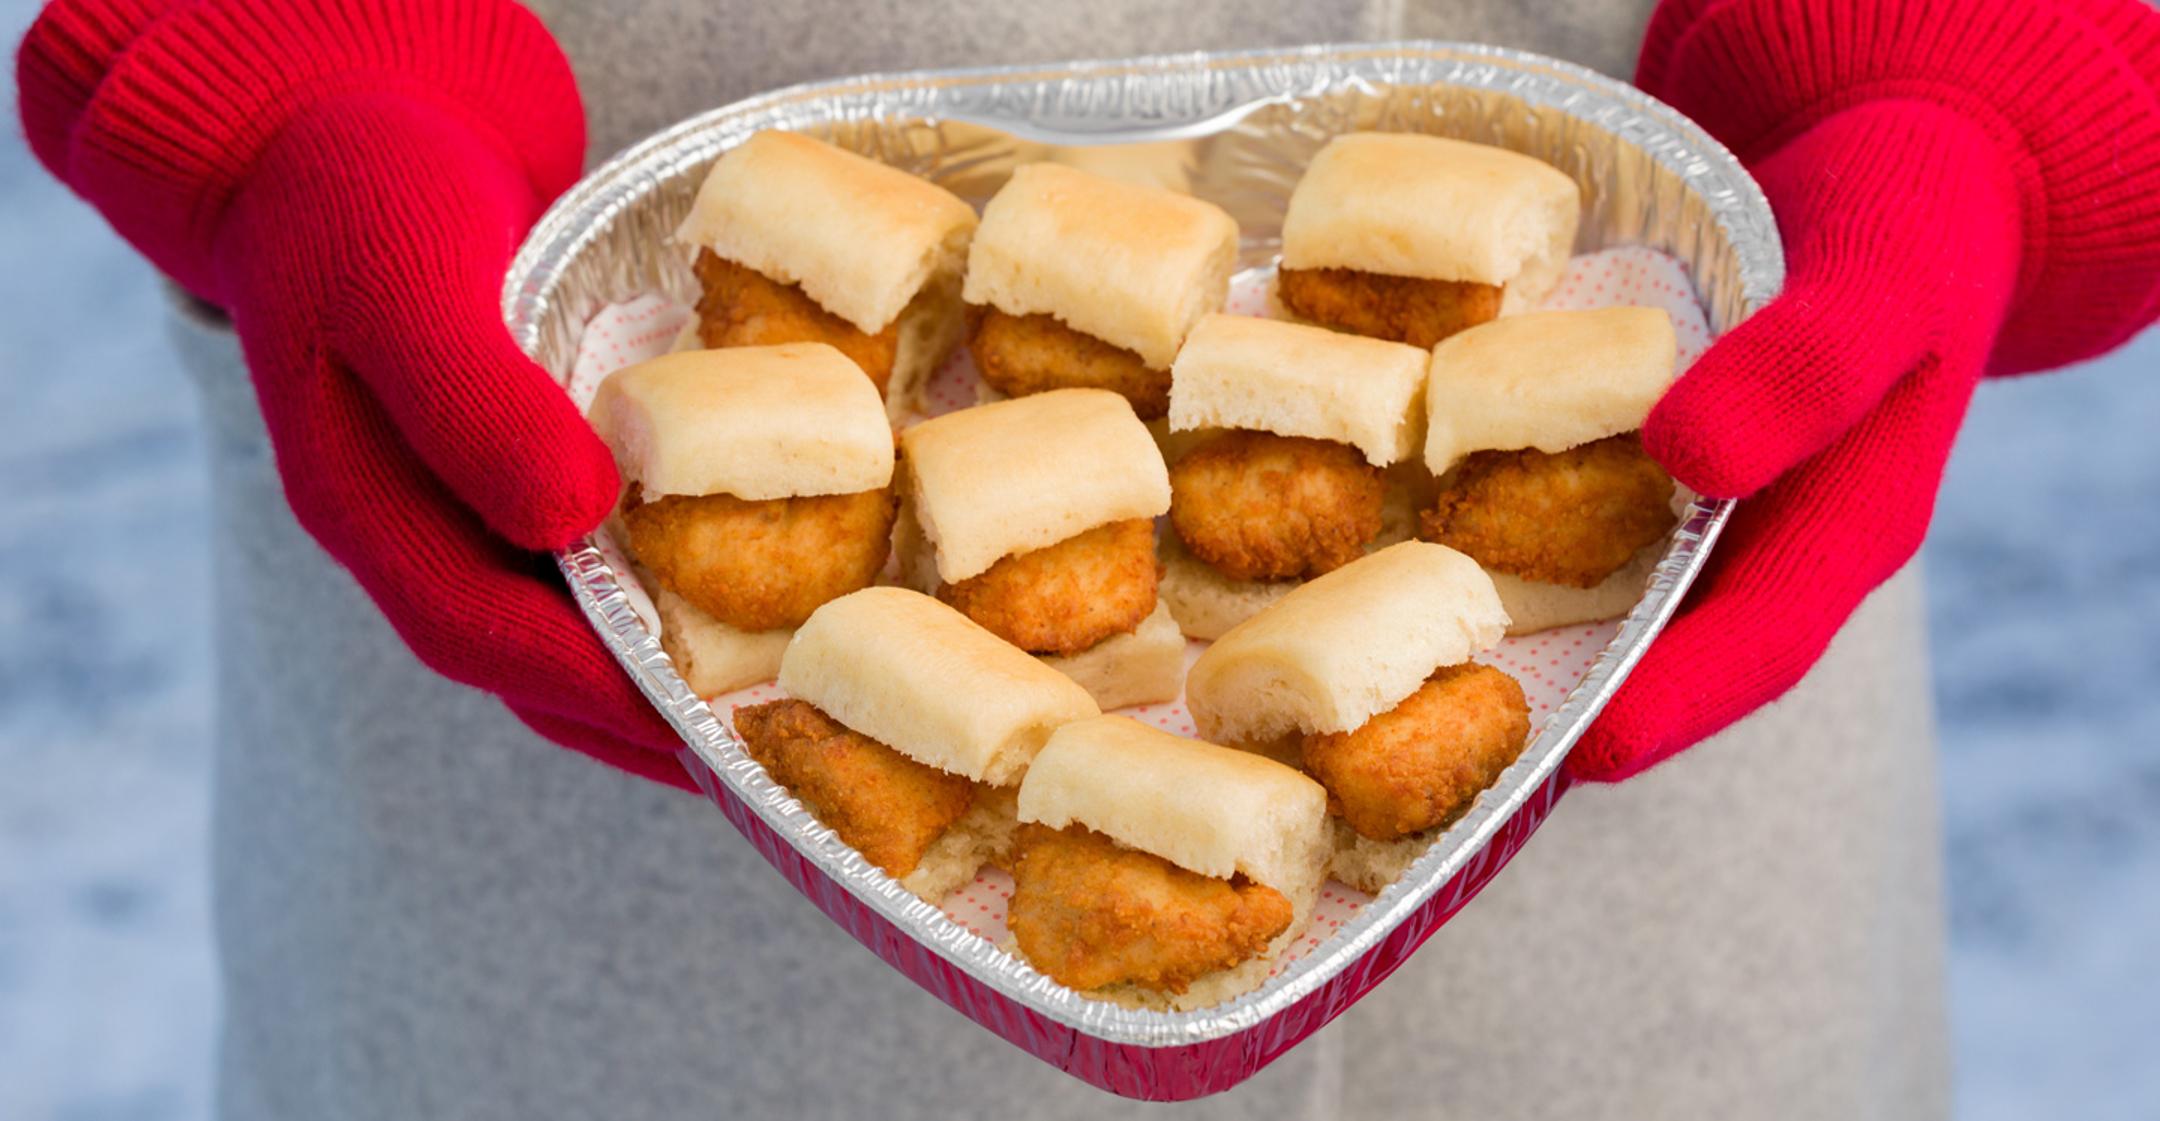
[696,248,901,395]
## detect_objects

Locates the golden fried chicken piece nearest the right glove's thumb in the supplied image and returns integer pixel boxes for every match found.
[1417,432,1678,587]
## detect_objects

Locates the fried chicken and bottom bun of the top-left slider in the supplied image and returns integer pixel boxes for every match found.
[676,248,966,423]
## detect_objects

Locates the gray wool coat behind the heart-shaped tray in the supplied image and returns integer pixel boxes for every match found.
[175,0,1946,1121]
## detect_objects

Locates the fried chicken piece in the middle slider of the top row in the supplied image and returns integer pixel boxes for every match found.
[968,307,1171,421]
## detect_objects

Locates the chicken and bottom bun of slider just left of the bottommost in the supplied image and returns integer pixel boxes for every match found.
[732,700,1013,903]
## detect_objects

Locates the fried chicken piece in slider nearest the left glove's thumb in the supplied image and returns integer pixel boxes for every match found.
[622,488,899,631]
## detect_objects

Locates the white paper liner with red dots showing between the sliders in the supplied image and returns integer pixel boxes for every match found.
[566,246,1711,968]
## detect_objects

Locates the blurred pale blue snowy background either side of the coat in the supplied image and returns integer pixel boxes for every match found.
[0,0,2160,1121]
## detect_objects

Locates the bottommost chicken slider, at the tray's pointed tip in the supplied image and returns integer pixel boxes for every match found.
[1007,717,1328,1009]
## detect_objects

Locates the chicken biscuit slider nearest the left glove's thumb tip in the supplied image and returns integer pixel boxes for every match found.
[590,343,899,698]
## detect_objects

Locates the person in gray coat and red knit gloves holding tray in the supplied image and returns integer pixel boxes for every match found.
[17,0,2160,1121]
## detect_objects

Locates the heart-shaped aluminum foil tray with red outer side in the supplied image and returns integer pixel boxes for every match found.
[503,43,1784,1099]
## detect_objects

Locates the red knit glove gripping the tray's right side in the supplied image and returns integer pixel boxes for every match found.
[1568,0,2160,780]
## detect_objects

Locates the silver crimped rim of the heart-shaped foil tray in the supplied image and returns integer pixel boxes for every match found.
[503,41,1784,1048]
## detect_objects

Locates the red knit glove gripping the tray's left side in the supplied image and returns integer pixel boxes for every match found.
[17,0,687,786]
